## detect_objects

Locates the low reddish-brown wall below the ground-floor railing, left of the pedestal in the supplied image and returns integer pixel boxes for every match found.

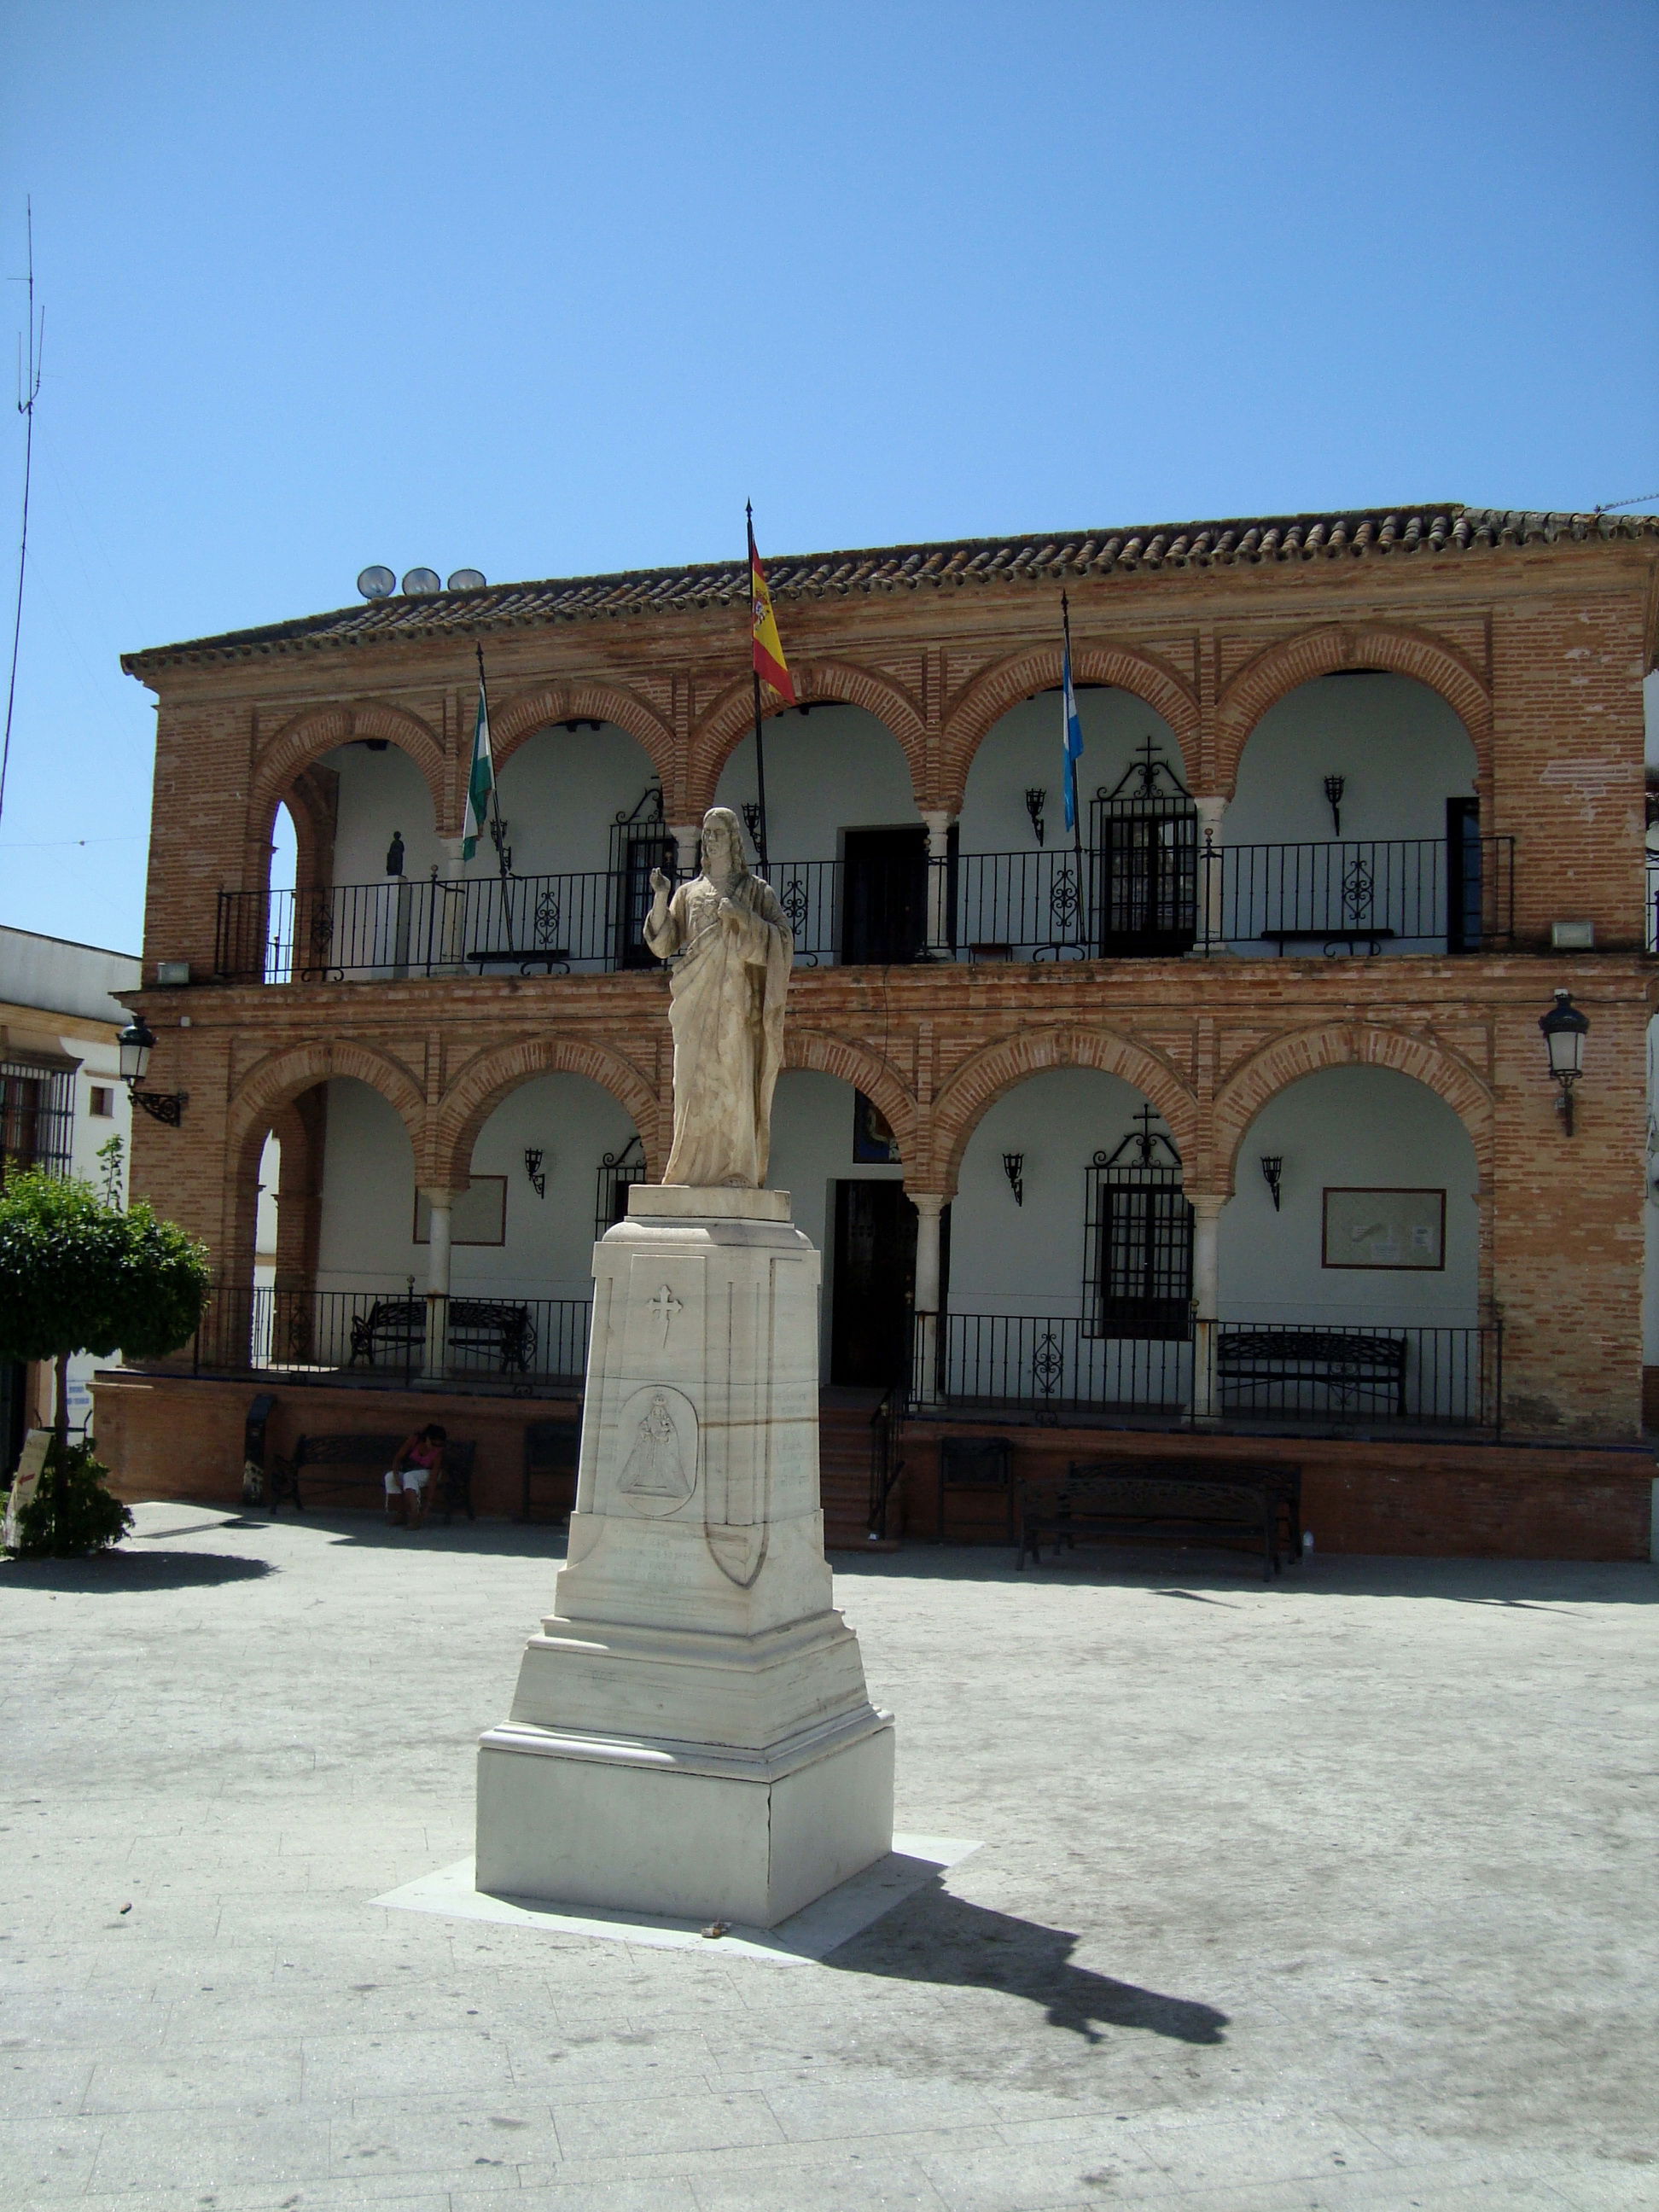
[93,1369,578,1516]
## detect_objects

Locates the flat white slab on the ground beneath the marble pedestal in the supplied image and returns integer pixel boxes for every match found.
[371,1836,980,1966]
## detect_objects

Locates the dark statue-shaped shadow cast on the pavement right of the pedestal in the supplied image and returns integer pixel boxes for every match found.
[825,1887,1228,2044]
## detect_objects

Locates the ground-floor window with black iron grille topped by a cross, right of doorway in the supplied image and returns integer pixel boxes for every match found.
[1084,1106,1192,1341]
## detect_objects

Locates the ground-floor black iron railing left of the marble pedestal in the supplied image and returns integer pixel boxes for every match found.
[190,1288,593,1385]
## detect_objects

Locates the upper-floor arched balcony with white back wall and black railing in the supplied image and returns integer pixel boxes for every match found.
[214,670,1516,982]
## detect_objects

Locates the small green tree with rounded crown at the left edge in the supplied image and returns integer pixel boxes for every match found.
[0,1168,208,1453]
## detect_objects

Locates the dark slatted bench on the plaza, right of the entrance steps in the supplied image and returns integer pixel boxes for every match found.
[1020,1458,1303,1581]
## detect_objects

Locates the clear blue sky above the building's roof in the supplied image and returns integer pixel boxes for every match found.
[0,0,1659,946]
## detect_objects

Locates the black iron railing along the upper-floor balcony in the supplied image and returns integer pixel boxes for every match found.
[217,836,1522,982]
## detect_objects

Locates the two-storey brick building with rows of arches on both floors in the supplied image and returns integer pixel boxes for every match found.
[97,507,1659,1557]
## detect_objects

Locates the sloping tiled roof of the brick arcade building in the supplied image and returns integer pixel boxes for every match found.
[122,507,1659,675]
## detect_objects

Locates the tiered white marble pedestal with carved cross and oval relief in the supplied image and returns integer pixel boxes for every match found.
[478,1184,894,1927]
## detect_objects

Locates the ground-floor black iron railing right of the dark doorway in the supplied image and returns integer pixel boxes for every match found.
[928,1314,1502,1434]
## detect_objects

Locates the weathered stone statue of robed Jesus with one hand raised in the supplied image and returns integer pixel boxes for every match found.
[643,807,795,1190]
